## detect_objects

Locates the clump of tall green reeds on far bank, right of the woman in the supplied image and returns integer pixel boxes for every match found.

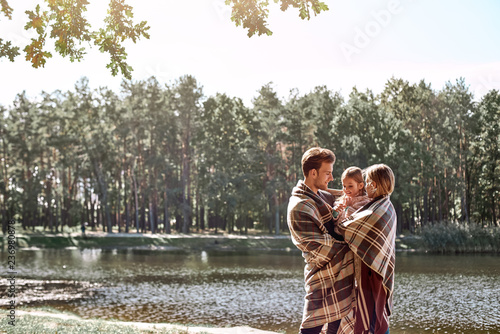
[421,222,500,253]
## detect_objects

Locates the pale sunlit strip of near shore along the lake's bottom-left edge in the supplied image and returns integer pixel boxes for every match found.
[16,310,277,334]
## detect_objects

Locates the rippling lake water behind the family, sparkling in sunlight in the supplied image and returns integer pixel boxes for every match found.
[1,249,500,334]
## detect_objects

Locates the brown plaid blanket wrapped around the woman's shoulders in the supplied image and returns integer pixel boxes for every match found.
[337,196,397,315]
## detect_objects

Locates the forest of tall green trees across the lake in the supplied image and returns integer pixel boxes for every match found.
[0,75,500,234]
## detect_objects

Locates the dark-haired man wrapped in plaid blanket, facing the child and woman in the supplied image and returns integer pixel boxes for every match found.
[287,147,355,334]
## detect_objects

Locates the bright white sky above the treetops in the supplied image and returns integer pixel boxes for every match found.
[0,0,500,106]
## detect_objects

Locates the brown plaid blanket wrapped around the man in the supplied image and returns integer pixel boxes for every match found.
[288,181,355,333]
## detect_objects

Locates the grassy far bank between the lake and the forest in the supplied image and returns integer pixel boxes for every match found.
[8,223,500,253]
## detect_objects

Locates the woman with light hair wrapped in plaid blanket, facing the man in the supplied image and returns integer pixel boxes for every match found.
[337,164,397,334]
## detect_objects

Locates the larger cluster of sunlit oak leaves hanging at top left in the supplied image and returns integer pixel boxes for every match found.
[0,0,150,79]
